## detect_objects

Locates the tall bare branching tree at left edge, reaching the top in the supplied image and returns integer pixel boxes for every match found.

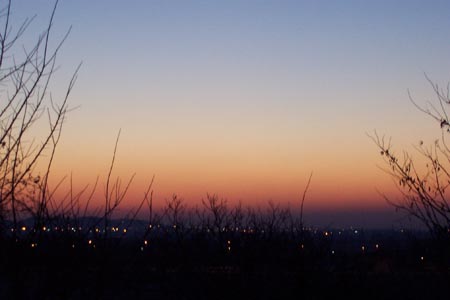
[0,1,79,232]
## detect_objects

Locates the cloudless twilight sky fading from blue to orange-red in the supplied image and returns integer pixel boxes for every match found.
[13,0,450,227]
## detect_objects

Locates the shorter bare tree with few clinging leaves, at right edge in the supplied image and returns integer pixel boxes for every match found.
[369,75,450,242]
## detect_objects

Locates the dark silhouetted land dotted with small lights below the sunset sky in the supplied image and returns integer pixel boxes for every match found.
[0,209,450,299]
